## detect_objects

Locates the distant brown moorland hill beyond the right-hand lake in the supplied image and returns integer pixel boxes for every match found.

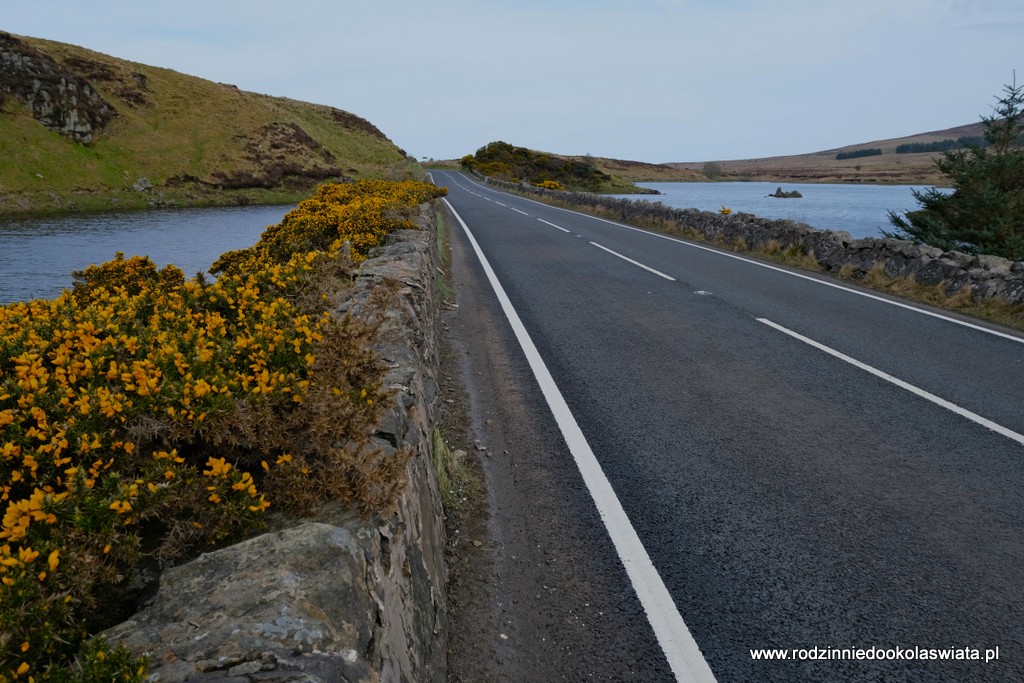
[666,122,984,185]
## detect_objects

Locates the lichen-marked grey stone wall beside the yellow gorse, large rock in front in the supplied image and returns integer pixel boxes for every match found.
[104,212,447,683]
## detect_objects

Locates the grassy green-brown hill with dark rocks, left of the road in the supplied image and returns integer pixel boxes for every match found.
[0,32,412,213]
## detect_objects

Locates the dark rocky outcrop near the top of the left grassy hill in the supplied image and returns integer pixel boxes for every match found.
[0,32,117,144]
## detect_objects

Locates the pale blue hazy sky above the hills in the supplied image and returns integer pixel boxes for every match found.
[0,0,1024,163]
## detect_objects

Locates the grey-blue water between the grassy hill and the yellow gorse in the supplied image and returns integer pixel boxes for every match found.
[0,206,294,303]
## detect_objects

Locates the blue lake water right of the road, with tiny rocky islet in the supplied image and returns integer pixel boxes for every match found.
[617,182,950,238]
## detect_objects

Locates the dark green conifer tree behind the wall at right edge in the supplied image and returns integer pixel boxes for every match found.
[886,78,1024,260]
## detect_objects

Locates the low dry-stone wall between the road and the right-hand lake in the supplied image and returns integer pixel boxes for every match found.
[481,176,1024,304]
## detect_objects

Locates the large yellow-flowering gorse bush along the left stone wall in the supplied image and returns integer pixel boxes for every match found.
[0,181,443,682]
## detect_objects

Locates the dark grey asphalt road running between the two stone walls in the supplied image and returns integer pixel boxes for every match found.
[433,172,1024,682]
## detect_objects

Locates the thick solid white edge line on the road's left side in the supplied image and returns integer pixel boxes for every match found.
[441,194,715,683]
